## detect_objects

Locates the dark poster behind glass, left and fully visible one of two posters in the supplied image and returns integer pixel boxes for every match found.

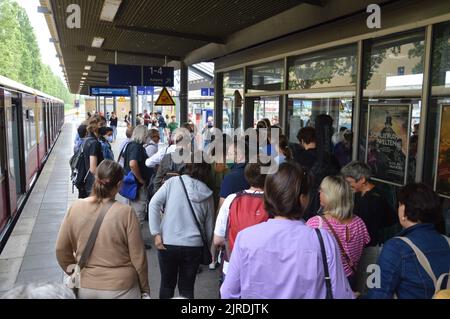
[366,104,411,186]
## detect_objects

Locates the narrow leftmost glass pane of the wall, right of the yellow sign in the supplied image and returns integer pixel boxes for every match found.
[222,69,244,134]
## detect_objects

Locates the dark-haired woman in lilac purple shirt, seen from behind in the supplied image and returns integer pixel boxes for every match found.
[220,163,354,299]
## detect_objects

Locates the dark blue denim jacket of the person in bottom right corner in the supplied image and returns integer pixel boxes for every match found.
[366,224,450,299]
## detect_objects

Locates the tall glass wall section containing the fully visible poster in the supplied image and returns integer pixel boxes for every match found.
[358,29,425,186]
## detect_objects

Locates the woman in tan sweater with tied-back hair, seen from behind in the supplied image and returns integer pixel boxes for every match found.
[56,160,150,299]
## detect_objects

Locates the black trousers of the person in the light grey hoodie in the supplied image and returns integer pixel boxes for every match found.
[158,245,202,299]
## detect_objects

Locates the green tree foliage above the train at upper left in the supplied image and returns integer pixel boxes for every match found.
[0,0,74,103]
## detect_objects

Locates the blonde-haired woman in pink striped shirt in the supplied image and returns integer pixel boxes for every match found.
[307,176,370,288]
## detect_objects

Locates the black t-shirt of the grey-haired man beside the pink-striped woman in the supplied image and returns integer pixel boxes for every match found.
[353,188,395,246]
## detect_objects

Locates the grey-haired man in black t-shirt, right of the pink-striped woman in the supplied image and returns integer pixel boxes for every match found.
[341,161,395,246]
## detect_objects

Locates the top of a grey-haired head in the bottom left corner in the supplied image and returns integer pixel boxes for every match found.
[0,283,75,299]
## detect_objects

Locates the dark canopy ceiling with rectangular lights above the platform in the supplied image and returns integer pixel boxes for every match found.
[39,0,380,94]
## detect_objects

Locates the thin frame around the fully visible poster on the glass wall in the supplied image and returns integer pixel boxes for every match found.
[365,103,412,187]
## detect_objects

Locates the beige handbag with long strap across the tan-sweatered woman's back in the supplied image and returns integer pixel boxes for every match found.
[65,200,116,298]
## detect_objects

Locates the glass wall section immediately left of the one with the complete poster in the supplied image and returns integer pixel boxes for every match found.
[286,45,357,147]
